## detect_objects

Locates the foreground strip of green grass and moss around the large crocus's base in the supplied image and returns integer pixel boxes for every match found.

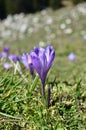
[0,58,86,130]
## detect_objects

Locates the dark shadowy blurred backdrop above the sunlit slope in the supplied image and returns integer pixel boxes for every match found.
[0,0,86,19]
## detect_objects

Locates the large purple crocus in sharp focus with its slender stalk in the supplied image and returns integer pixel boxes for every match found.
[30,46,55,98]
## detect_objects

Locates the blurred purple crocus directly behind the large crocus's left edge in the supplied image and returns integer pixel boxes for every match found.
[21,53,34,75]
